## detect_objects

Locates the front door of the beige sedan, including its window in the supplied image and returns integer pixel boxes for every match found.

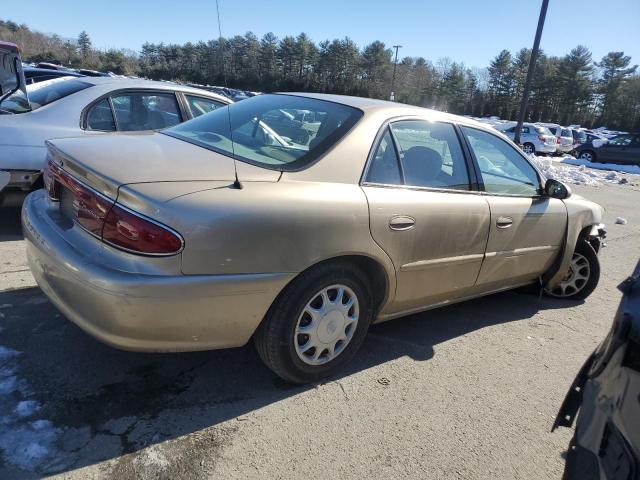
[461,127,567,291]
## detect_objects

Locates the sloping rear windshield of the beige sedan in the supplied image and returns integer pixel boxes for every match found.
[162,94,362,171]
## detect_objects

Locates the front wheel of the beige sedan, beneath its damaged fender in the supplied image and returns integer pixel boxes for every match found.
[545,240,600,300]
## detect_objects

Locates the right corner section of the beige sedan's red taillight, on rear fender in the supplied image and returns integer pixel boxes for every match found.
[102,205,182,255]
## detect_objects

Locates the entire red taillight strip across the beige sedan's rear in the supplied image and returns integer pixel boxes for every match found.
[44,160,183,255]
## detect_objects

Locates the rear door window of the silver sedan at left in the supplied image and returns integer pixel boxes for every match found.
[111,92,182,132]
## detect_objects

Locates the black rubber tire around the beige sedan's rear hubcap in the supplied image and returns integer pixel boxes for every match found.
[254,262,374,384]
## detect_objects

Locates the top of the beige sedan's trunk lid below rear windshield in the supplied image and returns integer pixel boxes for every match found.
[46,132,277,198]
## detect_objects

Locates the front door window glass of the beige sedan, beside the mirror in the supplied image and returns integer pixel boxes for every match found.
[461,127,540,196]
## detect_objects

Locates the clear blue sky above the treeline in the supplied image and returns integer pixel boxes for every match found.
[0,0,640,67]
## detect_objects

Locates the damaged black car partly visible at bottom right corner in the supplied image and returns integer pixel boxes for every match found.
[553,263,640,480]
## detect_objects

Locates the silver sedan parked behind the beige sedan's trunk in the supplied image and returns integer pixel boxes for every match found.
[0,76,231,205]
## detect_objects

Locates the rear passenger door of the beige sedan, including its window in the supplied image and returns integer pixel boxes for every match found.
[362,119,490,313]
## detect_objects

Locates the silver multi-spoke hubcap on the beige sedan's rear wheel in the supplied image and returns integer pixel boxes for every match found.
[293,284,360,365]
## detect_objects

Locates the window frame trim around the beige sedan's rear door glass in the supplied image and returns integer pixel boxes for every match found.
[360,116,478,193]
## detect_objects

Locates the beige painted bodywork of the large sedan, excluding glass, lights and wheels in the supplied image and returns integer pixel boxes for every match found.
[23,95,601,351]
